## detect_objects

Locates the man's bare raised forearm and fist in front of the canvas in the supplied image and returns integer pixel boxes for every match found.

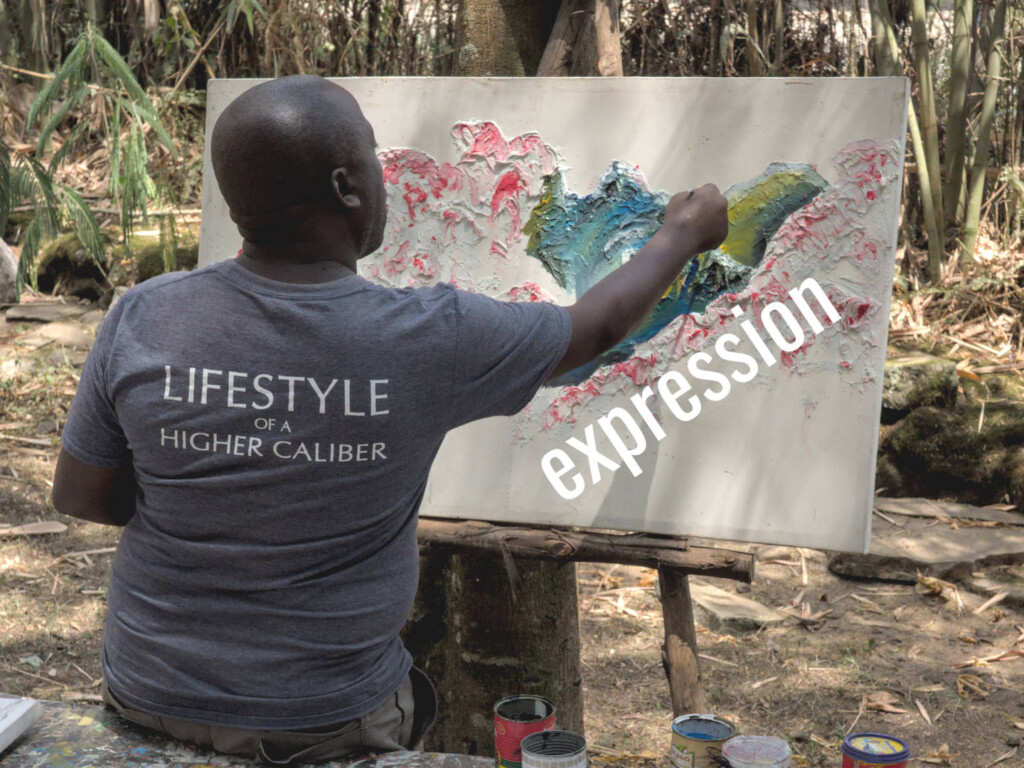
[550,184,729,378]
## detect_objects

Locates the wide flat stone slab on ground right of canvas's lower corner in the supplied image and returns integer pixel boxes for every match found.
[828,515,1024,584]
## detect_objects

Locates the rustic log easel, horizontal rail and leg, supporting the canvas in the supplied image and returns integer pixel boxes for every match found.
[418,518,754,717]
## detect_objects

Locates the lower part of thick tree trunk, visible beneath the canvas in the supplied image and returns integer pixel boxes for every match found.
[404,551,583,755]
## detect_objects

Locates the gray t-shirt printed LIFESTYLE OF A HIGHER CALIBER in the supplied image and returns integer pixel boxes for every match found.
[61,261,570,729]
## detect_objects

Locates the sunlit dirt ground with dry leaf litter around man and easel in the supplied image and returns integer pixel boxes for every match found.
[0,303,1024,768]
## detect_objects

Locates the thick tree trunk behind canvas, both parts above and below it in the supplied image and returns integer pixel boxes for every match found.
[403,0,583,755]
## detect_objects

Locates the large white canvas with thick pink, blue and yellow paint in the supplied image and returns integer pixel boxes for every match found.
[200,78,908,551]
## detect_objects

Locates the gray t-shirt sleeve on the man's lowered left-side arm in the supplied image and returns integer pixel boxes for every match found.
[60,299,129,469]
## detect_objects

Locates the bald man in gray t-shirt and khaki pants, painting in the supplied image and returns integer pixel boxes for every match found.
[53,76,727,763]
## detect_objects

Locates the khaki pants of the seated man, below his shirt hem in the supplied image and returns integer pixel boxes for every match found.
[102,667,437,765]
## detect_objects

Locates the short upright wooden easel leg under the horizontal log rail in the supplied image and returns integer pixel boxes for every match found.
[657,565,707,717]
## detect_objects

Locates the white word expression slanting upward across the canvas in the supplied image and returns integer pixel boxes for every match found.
[541,278,840,500]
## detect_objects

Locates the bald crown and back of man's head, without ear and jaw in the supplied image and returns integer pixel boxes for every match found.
[210,75,380,239]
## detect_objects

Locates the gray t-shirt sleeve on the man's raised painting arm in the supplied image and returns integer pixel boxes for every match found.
[451,291,572,434]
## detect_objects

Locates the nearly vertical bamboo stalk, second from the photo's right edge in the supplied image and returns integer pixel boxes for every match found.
[942,0,974,227]
